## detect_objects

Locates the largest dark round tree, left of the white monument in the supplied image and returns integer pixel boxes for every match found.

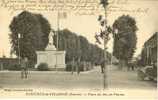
[9,11,50,64]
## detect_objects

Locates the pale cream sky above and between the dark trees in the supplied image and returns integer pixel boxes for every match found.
[0,0,158,57]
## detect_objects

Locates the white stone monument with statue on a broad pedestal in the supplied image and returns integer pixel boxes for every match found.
[36,31,65,70]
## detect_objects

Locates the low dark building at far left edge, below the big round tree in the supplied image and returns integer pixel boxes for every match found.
[0,57,19,70]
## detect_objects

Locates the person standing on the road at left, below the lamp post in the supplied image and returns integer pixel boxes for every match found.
[21,57,28,79]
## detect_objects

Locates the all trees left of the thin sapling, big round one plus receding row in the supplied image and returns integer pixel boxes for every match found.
[10,11,110,67]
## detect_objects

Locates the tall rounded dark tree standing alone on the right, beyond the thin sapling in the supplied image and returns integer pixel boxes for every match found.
[113,15,137,68]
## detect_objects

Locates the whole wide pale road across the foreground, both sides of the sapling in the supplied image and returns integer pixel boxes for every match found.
[0,65,156,90]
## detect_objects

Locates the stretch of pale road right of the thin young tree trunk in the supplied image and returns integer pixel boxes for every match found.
[105,66,157,89]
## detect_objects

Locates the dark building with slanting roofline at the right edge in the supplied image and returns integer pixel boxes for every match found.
[141,32,158,65]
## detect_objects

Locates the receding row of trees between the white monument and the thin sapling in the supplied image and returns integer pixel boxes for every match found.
[54,29,111,64]
